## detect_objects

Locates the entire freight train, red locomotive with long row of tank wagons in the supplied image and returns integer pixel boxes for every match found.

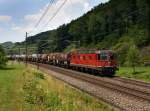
[8,50,118,76]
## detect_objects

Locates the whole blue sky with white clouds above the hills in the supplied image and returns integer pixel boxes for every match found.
[0,0,108,43]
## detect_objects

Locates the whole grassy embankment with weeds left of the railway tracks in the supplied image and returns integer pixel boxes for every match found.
[0,64,112,111]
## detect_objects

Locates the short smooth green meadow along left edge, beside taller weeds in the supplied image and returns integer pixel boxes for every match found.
[0,64,24,111]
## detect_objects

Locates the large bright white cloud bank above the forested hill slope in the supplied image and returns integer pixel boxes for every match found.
[0,0,109,41]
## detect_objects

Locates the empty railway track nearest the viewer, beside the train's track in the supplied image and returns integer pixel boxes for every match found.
[42,62,150,102]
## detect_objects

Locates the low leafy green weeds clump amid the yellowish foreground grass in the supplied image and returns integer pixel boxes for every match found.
[23,72,62,111]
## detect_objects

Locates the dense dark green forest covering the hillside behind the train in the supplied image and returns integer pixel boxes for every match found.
[6,0,150,65]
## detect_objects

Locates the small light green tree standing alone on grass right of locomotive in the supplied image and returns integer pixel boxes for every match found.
[126,45,140,73]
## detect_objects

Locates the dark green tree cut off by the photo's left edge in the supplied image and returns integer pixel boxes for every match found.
[0,46,7,67]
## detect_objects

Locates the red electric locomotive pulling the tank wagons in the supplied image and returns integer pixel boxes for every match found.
[70,50,118,75]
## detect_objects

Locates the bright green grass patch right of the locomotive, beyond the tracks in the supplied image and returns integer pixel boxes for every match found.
[117,67,150,82]
